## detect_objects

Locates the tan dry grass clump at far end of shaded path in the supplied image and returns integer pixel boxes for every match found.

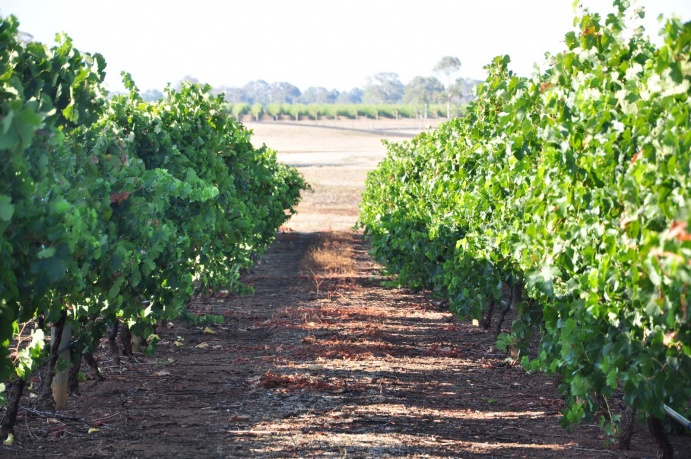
[301,231,355,277]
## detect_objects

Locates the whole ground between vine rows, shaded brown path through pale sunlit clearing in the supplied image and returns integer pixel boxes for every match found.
[0,122,691,458]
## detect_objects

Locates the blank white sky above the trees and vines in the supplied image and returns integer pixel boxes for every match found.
[0,0,691,91]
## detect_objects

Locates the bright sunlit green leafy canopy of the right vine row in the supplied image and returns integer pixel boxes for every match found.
[360,2,691,434]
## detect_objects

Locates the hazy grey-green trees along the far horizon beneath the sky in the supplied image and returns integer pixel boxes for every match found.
[142,56,480,107]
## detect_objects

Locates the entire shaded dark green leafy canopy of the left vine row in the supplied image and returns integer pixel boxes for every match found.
[0,16,307,406]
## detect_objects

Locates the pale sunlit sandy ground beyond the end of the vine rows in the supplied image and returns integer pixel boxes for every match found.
[245,119,439,231]
